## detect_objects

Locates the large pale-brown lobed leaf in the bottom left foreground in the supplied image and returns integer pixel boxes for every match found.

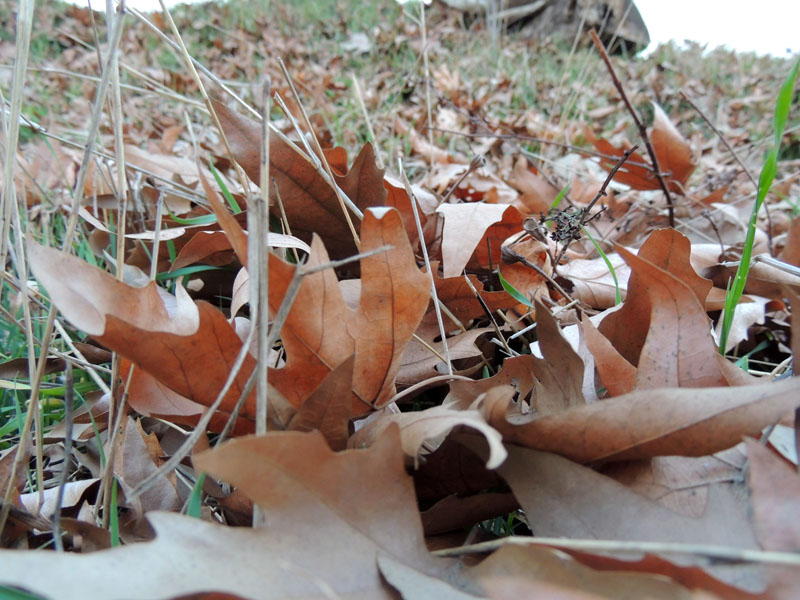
[0,431,458,600]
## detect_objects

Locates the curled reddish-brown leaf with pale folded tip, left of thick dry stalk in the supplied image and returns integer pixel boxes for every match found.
[26,243,255,429]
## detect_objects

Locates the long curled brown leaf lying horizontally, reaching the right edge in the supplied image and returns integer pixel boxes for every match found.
[482,378,800,463]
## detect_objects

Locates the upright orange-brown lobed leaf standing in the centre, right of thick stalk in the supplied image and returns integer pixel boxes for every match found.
[269,209,430,414]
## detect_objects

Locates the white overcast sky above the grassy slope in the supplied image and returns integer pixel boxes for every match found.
[70,0,800,57]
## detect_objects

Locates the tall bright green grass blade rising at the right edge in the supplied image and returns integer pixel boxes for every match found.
[719,58,800,354]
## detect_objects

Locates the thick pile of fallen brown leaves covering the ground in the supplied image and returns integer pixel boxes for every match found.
[0,0,800,599]
